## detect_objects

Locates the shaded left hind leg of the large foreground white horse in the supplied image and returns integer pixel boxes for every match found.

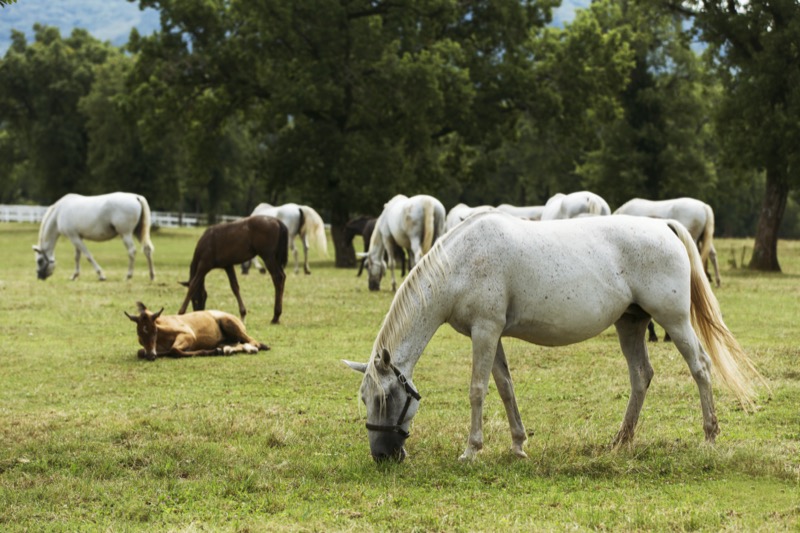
[613,313,653,446]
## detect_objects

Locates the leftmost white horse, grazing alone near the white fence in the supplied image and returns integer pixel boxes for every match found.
[33,192,155,281]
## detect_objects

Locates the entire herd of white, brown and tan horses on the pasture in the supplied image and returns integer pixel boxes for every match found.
[33,191,763,461]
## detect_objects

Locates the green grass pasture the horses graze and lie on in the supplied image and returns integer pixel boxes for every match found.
[0,224,800,531]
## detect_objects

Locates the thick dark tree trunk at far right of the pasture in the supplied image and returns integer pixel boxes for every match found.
[749,166,789,272]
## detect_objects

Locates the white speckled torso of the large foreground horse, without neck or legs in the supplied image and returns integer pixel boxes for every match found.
[441,213,690,345]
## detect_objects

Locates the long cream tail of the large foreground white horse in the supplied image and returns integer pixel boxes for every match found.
[668,220,769,408]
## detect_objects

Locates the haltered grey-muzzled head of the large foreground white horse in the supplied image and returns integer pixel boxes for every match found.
[344,349,420,462]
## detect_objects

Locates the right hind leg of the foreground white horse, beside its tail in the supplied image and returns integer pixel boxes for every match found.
[666,319,719,443]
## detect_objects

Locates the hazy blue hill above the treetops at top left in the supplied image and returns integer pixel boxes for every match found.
[0,0,160,57]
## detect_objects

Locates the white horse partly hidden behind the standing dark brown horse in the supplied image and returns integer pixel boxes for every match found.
[242,204,328,274]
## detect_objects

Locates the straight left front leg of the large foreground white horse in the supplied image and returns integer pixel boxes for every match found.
[459,325,500,461]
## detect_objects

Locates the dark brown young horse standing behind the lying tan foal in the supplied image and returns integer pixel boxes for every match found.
[178,215,289,324]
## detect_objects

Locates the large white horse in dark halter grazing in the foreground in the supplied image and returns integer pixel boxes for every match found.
[345,213,758,460]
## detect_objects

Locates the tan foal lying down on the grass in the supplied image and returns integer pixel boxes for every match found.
[125,302,269,361]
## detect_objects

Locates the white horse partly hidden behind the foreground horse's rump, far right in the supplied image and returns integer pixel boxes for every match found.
[614,197,720,287]
